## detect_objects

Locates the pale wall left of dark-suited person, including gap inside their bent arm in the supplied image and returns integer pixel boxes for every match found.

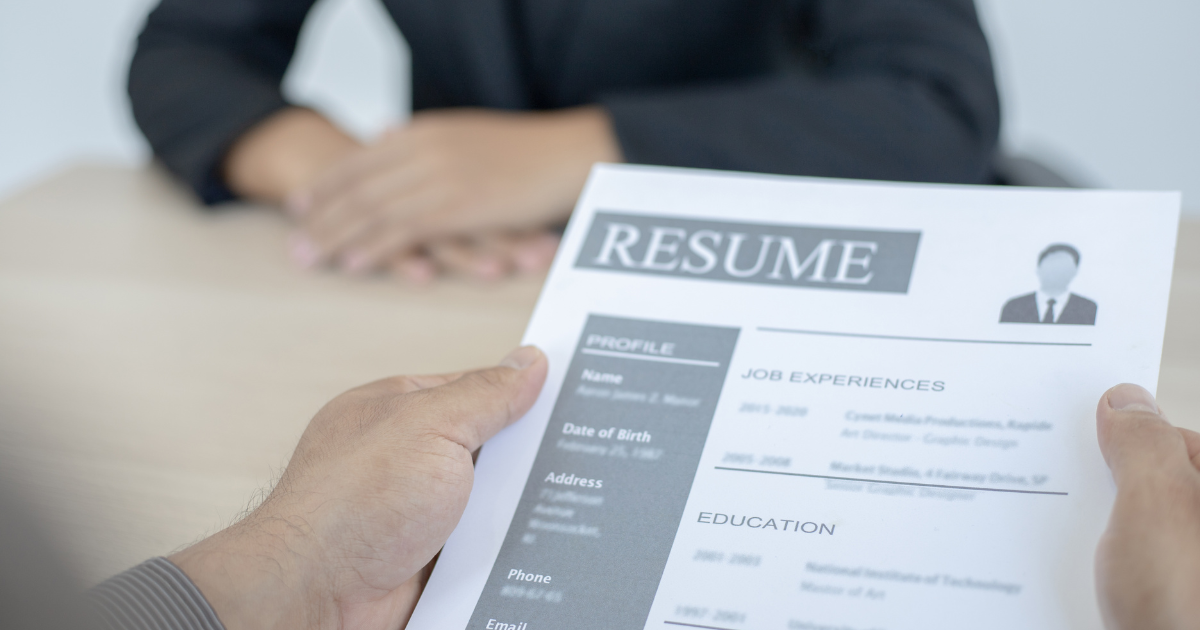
[0,0,408,198]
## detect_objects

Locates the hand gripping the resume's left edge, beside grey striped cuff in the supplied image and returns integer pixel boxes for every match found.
[170,347,547,630]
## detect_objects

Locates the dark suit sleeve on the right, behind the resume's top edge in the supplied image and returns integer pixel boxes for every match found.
[601,0,1000,184]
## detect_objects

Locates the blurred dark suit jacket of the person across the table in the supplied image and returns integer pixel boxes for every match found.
[128,0,1000,203]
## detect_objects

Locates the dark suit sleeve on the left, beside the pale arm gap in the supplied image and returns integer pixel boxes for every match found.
[128,0,314,204]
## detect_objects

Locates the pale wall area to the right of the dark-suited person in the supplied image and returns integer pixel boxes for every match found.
[977,0,1200,199]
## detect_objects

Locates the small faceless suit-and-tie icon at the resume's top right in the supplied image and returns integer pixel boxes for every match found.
[1000,242,1096,326]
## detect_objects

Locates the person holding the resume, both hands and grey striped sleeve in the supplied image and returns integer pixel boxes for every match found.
[0,347,1200,630]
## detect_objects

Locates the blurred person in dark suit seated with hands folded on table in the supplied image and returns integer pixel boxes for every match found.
[128,0,1000,280]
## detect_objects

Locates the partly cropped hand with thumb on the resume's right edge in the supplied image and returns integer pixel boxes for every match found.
[1096,384,1200,630]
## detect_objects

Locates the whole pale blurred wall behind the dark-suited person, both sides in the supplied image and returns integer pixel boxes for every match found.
[0,0,1200,216]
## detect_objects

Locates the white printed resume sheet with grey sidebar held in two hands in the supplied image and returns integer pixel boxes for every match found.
[409,166,1180,630]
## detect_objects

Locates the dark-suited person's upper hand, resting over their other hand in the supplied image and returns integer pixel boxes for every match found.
[280,107,620,272]
